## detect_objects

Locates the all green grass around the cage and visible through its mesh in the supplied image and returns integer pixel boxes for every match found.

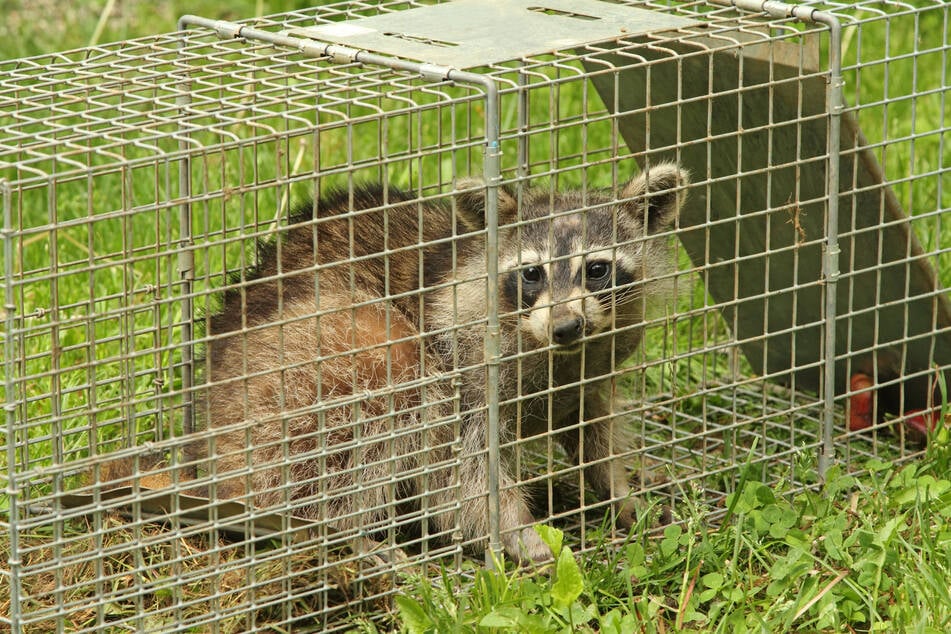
[0,0,951,632]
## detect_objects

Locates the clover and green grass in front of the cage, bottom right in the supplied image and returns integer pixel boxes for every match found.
[384,446,951,634]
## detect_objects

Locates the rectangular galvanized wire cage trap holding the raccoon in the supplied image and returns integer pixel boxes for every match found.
[0,0,951,632]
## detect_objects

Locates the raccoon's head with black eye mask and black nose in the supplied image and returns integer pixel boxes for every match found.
[458,164,688,354]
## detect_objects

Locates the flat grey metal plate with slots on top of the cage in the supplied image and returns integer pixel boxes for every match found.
[287,0,698,69]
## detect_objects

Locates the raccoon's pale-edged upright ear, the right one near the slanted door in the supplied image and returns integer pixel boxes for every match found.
[621,163,690,233]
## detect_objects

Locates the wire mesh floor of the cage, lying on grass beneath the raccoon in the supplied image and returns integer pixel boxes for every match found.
[5,381,917,631]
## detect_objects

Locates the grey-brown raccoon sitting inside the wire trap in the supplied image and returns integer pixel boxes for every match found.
[199,164,688,562]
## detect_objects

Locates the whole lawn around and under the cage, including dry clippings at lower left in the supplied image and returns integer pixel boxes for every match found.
[0,0,951,633]
